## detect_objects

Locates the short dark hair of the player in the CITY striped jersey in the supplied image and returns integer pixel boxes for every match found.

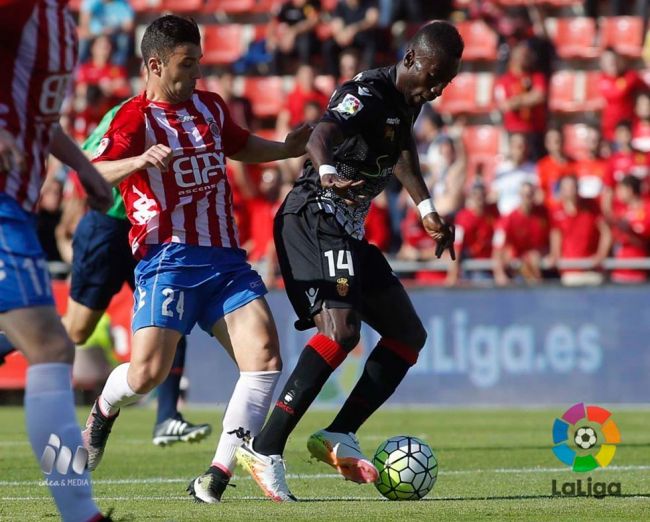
[140,15,201,66]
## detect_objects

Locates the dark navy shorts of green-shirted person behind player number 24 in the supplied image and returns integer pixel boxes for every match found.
[70,210,136,310]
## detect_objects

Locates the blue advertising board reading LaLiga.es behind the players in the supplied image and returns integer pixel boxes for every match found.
[187,286,650,405]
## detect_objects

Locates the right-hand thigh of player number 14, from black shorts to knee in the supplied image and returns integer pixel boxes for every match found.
[362,245,426,349]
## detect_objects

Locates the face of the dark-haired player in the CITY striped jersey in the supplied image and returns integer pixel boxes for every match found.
[160,43,203,103]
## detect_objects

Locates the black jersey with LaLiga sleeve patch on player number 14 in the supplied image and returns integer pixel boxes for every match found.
[282,66,420,239]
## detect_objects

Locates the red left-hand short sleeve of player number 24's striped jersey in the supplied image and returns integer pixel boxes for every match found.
[93,101,145,162]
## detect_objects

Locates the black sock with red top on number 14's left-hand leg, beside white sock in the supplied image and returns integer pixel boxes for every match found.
[253,334,347,455]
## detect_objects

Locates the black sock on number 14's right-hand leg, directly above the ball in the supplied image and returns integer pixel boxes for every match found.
[326,339,417,433]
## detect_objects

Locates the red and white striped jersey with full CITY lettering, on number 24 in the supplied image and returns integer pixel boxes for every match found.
[94,90,249,255]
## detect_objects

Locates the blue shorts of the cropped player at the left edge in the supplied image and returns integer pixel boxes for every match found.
[0,193,54,313]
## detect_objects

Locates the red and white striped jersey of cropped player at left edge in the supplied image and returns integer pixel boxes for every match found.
[0,0,77,212]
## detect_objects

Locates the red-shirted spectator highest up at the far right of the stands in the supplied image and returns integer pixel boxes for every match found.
[598,47,646,142]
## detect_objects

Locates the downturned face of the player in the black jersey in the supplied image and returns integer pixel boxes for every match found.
[401,49,460,106]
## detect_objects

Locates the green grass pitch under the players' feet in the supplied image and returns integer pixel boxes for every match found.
[0,407,650,522]
